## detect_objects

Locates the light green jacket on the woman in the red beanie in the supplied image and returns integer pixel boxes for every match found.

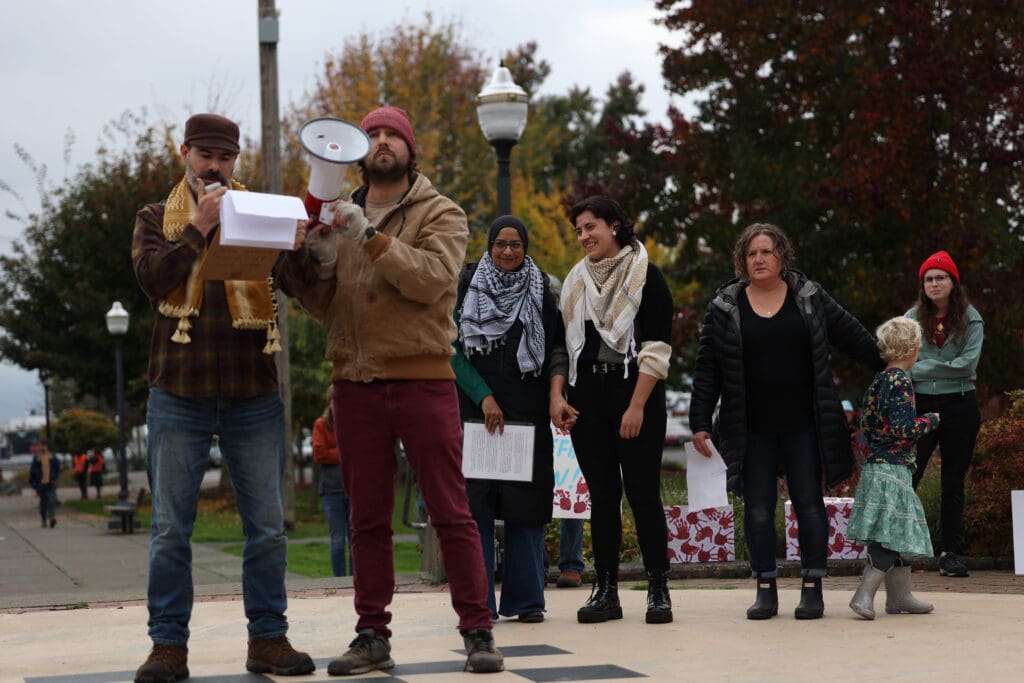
[906,304,985,395]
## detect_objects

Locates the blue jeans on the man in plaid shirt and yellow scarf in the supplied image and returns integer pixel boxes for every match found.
[146,388,288,645]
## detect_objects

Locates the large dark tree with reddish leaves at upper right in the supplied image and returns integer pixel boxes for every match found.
[656,0,1024,391]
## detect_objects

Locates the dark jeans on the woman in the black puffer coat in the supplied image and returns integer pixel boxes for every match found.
[743,425,828,579]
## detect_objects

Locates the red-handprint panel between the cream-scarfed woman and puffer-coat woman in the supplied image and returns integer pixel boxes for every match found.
[665,505,736,563]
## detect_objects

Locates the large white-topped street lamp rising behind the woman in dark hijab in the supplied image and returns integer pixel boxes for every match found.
[476,61,529,216]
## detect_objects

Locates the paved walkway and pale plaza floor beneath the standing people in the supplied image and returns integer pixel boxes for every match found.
[0,489,1024,683]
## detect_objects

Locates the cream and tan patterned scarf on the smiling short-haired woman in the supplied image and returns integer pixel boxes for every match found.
[560,242,647,386]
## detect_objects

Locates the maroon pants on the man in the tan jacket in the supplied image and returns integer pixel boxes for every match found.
[333,380,490,638]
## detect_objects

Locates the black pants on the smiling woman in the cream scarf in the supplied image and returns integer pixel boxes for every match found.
[568,370,669,572]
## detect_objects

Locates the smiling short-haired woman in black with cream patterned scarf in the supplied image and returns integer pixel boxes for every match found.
[550,197,673,624]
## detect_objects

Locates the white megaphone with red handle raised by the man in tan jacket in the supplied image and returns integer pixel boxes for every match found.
[299,117,370,224]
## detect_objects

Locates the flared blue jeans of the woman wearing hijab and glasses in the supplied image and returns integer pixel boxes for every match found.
[476,501,547,616]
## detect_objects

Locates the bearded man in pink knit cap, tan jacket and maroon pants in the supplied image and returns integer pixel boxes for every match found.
[278,106,504,676]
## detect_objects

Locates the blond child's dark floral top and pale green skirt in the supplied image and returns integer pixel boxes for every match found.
[847,368,939,557]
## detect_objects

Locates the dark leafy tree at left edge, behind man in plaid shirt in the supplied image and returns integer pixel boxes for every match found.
[0,112,182,417]
